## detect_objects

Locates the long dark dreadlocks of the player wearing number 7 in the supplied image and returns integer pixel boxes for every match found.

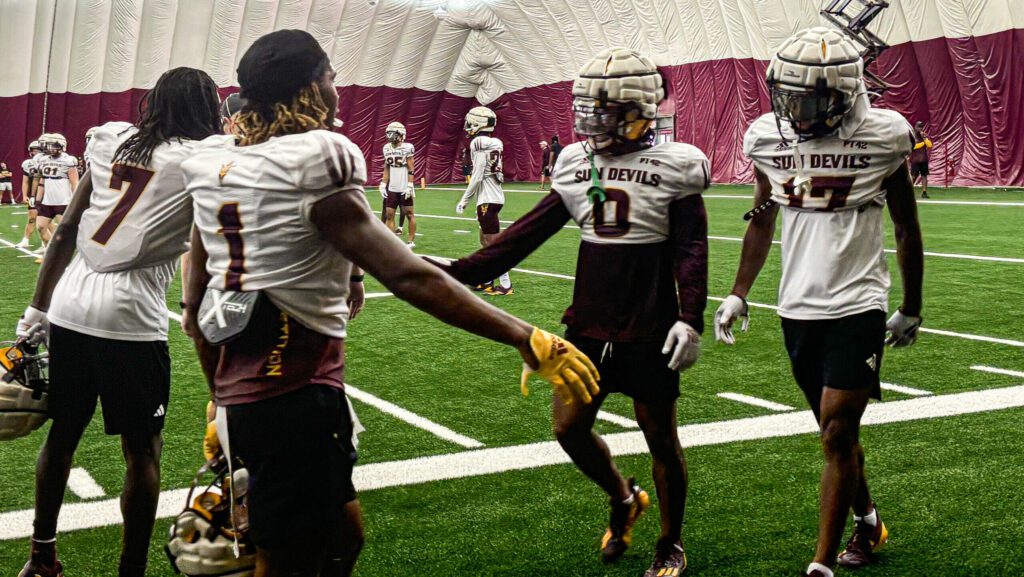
[114,67,220,166]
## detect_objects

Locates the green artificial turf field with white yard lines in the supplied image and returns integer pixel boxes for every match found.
[0,184,1024,577]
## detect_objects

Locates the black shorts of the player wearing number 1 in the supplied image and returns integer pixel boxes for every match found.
[227,384,356,549]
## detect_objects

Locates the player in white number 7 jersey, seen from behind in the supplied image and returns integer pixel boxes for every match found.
[17,68,220,577]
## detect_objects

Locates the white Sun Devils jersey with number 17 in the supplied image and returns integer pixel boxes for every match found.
[743,109,913,320]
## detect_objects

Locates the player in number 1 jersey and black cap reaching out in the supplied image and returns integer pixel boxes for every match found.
[183,30,598,577]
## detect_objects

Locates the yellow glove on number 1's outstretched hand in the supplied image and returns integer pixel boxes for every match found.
[519,327,601,405]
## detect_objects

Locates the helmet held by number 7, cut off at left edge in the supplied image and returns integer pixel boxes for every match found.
[0,340,49,441]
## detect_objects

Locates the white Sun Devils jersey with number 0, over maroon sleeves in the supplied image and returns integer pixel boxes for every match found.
[551,142,711,244]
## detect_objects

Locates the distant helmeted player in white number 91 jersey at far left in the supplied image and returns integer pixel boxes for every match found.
[36,133,78,259]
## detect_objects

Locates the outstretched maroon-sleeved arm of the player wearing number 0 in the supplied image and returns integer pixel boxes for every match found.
[442,192,570,285]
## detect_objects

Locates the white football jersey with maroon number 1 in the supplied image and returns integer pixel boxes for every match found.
[182,130,369,338]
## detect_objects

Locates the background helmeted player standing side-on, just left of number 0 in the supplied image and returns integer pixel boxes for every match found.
[455,107,514,296]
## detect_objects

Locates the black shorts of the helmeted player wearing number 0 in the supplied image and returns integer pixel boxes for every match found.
[565,333,679,403]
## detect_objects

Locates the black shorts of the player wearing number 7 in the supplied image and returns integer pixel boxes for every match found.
[49,324,171,435]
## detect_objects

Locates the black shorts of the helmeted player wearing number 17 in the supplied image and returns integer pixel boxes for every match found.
[782,311,886,409]
